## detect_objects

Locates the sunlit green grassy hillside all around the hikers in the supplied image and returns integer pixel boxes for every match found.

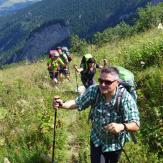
[0,1,163,163]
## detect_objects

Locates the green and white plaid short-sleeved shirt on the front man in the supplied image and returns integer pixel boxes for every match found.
[76,85,140,152]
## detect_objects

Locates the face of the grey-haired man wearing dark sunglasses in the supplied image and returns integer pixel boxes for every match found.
[99,73,119,95]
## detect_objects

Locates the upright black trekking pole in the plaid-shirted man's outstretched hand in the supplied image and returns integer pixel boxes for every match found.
[52,96,60,163]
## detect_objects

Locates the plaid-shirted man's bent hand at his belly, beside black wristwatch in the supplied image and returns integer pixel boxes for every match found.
[104,123,124,134]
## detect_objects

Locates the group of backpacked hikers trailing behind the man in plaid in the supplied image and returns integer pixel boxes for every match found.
[47,47,103,89]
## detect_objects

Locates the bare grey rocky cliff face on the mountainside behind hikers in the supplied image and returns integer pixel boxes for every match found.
[7,22,70,63]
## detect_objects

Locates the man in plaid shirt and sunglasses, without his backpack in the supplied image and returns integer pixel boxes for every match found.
[53,67,140,163]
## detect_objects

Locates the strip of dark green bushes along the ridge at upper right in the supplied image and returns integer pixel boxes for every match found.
[92,3,163,46]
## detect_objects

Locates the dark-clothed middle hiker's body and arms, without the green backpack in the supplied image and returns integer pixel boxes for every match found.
[74,58,101,89]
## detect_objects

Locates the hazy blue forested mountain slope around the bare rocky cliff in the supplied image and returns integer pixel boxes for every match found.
[0,0,148,64]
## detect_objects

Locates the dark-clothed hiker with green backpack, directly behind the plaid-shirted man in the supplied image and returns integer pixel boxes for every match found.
[74,54,101,89]
